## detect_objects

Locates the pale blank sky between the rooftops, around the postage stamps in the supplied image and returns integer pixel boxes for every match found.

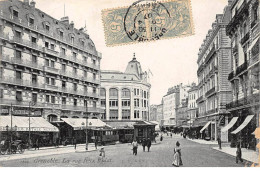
[35,0,228,104]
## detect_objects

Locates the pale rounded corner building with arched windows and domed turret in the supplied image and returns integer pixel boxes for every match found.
[100,54,151,121]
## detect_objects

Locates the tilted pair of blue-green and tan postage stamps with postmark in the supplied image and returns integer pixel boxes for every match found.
[102,0,194,46]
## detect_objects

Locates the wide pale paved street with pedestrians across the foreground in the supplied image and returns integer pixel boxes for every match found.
[0,136,248,167]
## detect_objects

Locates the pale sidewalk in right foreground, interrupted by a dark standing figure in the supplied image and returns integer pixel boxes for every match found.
[213,147,260,163]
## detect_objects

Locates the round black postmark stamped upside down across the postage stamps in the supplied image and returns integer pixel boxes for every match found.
[124,0,170,42]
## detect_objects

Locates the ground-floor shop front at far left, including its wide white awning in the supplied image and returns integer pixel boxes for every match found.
[0,116,59,147]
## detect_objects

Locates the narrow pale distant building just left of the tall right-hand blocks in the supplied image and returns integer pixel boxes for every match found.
[187,83,198,125]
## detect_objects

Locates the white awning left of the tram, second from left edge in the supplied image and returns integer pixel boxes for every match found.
[61,118,108,130]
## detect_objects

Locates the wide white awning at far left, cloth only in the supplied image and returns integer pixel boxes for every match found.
[0,116,59,132]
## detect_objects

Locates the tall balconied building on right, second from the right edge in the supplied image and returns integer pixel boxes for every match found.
[197,1,232,141]
